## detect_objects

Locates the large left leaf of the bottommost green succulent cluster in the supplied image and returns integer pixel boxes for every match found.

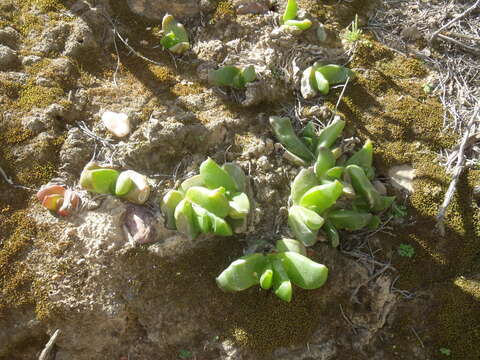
[216,254,267,291]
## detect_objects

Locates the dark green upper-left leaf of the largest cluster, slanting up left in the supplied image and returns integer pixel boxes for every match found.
[270,116,313,161]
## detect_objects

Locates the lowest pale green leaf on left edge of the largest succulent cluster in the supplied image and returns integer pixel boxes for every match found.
[288,205,323,246]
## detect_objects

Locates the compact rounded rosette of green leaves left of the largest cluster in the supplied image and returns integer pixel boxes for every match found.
[161,158,250,240]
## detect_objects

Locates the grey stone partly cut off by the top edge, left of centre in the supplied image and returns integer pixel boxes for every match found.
[127,0,200,20]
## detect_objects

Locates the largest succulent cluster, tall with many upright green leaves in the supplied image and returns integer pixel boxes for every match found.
[270,116,395,247]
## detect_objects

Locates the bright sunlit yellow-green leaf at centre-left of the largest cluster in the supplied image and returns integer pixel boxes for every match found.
[300,180,343,214]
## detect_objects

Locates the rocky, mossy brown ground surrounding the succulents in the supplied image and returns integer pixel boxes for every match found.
[0,0,480,360]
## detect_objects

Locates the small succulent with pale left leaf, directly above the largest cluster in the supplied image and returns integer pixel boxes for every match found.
[300,63,355,99]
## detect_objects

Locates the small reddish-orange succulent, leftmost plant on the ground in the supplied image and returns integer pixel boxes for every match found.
[37,185,80,216]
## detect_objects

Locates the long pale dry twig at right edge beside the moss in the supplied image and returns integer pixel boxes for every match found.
[437,104,480,236]
